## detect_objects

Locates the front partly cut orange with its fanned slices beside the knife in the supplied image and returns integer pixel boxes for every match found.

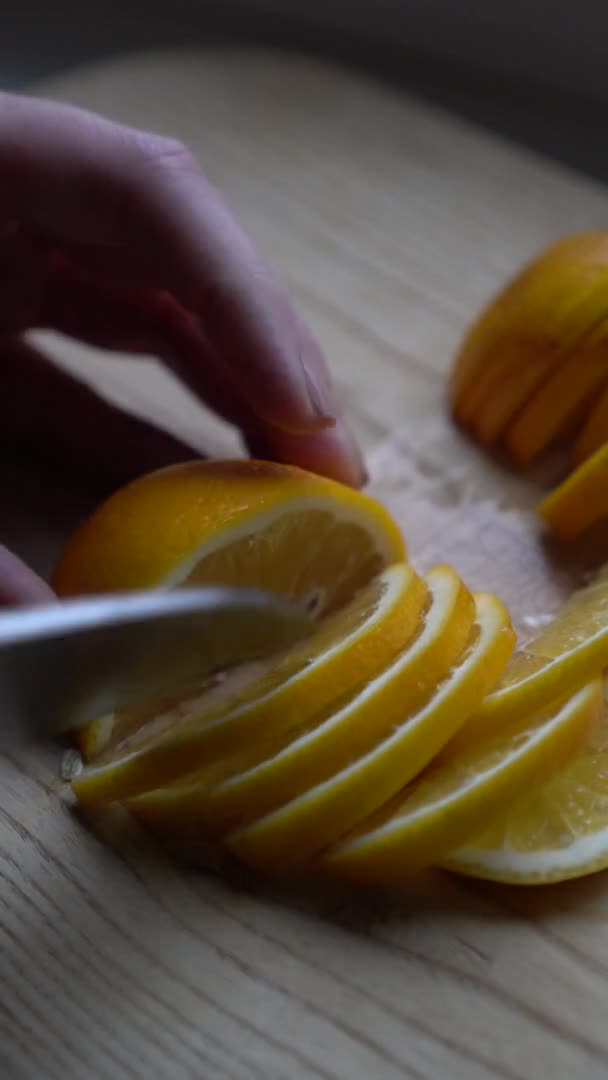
[55,462,608,882]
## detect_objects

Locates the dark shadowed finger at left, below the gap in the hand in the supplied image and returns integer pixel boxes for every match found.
[0,340,203,487]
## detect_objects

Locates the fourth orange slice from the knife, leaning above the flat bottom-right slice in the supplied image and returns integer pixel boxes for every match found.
[322,679,602,882]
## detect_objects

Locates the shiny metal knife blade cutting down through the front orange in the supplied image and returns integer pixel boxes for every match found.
[0,588,313,752]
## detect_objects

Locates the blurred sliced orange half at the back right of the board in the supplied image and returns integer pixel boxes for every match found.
[450,232,608,540]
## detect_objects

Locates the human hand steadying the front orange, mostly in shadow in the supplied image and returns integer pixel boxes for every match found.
[0,94,365,604]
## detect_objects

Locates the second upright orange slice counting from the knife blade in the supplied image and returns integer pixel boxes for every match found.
[132,566,475,832]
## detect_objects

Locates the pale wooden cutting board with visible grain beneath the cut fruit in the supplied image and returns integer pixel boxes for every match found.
[0,52,608,1080]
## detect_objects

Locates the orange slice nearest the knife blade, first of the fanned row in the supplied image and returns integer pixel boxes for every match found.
[73,563,428,805]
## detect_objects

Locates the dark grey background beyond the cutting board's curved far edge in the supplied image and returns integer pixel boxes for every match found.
[0,0,608,181]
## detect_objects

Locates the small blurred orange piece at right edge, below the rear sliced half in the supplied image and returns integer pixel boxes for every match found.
[539,443,608,540]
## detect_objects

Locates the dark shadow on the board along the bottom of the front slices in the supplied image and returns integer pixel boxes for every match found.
[75,808,608,941]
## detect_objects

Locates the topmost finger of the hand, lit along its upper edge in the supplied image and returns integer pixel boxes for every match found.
[0,95,336,432]
